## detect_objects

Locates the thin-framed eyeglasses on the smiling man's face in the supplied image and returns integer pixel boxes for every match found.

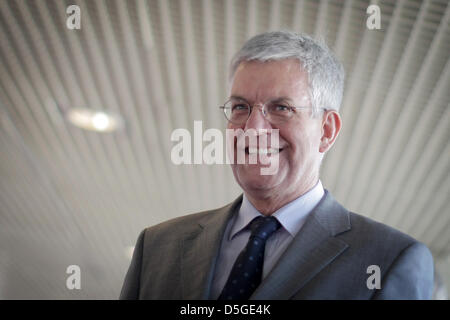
[219,98,327,125]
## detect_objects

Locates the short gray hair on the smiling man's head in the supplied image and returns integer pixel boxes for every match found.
[229,31,345,114]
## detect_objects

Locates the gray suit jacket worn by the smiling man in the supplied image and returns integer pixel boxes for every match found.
[120,191,433,300]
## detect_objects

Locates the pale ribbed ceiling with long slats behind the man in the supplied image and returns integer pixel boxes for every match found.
[0,0,450,299]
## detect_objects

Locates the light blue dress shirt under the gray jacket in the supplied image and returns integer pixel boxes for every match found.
[210,180,325,299]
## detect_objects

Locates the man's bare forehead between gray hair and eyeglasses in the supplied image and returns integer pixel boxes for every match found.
[231,59,309,101]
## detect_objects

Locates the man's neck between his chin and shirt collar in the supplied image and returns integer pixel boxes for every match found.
[245,178,319,216]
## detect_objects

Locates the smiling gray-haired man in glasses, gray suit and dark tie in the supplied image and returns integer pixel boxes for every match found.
[120,32,433,300]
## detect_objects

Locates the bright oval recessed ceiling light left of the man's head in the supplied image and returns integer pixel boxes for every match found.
[66,108,123,132]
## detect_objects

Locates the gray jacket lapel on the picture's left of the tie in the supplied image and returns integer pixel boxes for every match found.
[180,196,242,300]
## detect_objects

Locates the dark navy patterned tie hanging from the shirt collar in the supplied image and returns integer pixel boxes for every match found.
[218,217,280,300]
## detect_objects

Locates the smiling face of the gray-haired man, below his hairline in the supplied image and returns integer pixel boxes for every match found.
[228,59,322,198]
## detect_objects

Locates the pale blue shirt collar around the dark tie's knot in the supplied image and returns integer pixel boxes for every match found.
[229,180,325,240]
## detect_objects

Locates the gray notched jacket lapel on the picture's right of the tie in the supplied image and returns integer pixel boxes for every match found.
[250,191,351,300]
